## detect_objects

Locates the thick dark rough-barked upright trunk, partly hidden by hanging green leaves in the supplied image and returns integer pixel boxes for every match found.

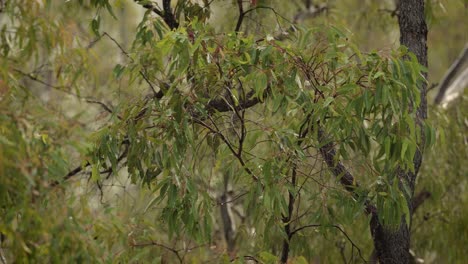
[370,0,427,264]
